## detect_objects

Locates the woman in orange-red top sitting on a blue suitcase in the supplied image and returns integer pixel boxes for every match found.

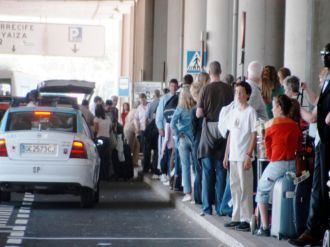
[255,95,301,236]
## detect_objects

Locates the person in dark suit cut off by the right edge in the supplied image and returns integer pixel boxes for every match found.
[289,43,330,246]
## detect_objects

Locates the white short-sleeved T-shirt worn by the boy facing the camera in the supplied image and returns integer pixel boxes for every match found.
[228,106,257,161]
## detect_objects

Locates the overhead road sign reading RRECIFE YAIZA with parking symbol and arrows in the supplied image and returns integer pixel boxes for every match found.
[0,21,105,57]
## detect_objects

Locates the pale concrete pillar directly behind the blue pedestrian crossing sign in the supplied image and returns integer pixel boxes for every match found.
[179,0,206,76]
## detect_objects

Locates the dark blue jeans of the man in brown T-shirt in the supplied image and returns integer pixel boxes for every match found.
[202,157,227,214]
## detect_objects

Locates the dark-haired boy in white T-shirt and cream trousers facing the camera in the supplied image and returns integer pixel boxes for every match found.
[223,82,257,231]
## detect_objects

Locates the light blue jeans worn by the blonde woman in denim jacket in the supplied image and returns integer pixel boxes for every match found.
[178,136,197,194]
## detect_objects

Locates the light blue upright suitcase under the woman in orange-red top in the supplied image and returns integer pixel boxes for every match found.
[271,173,297,240]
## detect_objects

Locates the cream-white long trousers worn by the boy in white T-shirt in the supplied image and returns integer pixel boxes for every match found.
[230,161,253,223]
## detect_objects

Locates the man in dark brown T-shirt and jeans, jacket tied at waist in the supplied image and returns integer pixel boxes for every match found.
[196,61,233,216]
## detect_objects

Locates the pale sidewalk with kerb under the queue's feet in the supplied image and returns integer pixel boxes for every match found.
[143,175,292,247]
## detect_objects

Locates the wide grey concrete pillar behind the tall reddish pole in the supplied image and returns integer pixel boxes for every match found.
[237,0,286,75]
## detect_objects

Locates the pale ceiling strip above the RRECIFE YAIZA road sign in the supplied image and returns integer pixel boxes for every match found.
[0,0,134,20]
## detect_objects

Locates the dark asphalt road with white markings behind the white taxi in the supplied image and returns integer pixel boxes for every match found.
[0,182,224,247]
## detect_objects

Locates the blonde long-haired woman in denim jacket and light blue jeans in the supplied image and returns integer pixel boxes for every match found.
[171,86,197,202]
